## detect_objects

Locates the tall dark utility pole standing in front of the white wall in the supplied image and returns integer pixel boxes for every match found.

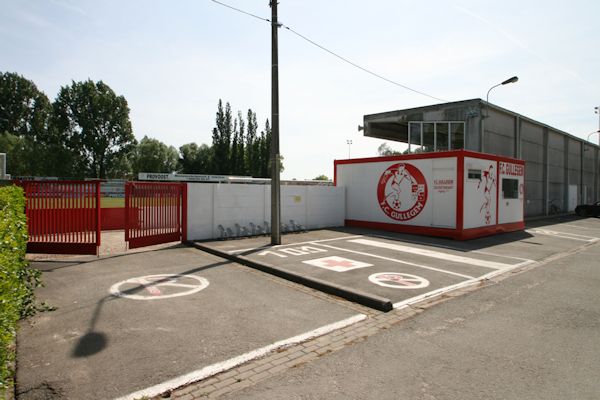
[269,0,281,246]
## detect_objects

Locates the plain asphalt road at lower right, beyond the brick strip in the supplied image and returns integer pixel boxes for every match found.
[224,236,600,400]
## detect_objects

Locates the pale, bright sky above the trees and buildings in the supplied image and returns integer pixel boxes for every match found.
[0,0,600,180]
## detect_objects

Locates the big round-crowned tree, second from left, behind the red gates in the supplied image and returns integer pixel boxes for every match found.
[52,80,136,178]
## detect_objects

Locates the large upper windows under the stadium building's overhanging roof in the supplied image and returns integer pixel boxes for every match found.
[408,121,465,153]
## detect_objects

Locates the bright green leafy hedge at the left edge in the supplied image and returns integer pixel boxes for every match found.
[0,186,40,394]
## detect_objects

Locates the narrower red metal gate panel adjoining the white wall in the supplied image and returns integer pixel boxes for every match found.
[125,182,187,249]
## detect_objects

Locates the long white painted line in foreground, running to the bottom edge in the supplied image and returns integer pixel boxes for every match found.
[115,314,367,400]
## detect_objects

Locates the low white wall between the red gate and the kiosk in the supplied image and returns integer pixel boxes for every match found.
[187,183,346,240]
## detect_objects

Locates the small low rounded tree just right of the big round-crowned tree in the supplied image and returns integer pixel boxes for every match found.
[132,136,179,175]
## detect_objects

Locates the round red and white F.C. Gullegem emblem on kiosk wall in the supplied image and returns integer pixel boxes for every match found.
[377,163,427,221]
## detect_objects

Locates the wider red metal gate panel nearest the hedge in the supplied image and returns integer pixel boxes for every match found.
[17,181,100,254]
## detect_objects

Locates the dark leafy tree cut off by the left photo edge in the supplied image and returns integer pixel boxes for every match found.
[0,72,55,176]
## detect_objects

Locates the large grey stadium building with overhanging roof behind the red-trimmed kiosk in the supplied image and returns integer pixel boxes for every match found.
[363,99,600,217]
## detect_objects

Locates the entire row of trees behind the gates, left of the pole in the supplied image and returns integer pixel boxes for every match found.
[0,72,278,178]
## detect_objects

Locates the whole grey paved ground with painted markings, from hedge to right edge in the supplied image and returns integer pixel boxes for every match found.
[17,218,600,400]
